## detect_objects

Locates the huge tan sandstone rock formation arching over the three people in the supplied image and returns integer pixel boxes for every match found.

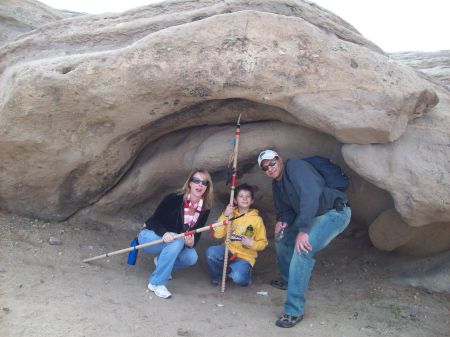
[0,0,450,256]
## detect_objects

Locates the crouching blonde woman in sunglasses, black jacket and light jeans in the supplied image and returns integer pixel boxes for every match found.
[138,169,213,298]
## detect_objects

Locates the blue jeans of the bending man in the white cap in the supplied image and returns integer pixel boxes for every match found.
[275,207,351,316]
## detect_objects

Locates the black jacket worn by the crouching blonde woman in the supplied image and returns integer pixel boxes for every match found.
[145,193,210,245]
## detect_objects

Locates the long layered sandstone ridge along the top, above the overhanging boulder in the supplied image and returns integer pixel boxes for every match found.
[0,0,382,72]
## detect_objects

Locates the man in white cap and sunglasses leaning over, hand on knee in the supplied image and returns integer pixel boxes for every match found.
[258,150,351,328]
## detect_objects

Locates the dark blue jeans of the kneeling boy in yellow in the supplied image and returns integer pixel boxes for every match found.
[206,245,252,286]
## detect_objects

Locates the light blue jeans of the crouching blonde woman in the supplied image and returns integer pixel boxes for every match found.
[138,229,198,286]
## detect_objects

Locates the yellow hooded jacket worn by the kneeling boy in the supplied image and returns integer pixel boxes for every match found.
[214,207,268,267]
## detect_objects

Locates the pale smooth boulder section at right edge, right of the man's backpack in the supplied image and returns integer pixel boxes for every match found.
[342,87,450,226]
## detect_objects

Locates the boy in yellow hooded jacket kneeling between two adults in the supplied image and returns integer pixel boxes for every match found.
[206,184,268,286]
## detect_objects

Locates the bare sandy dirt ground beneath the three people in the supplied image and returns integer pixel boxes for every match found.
[0,213,450,337]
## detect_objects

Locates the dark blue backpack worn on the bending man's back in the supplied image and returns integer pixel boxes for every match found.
[288,156,350,192]
